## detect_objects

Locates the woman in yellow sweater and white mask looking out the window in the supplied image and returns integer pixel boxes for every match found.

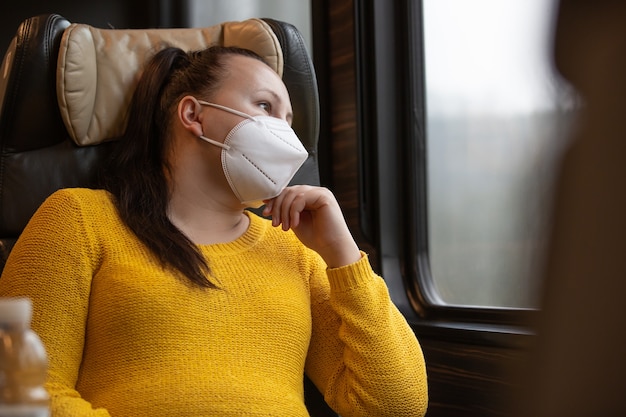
[0,47,427,417]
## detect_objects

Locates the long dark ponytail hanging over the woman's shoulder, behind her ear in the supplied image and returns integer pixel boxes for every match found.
[104,48,210,288]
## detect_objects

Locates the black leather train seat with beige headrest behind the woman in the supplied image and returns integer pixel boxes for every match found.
[0,14,335,416]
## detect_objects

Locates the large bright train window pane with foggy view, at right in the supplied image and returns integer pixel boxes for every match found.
[422,0,571,308]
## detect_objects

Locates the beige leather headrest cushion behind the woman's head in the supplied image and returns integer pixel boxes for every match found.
[57,19,283,146]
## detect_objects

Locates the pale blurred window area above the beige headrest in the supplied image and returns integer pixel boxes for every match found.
[187,0,312,54]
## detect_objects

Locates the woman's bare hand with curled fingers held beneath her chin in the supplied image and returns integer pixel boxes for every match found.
[263,185,361,268]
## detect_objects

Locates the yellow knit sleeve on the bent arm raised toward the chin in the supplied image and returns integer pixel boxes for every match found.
[306,250,428,417]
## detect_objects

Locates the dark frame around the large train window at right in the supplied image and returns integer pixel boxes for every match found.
[355,0,537,338]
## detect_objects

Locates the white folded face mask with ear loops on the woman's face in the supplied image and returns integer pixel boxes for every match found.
[198,100,309,208]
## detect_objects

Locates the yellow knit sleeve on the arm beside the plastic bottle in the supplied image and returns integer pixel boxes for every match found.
[0,191,109,417]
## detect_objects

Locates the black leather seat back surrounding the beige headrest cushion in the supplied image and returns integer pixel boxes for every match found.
[0,14,319,272]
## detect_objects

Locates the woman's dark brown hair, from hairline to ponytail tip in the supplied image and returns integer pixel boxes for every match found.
[102,46,263,288]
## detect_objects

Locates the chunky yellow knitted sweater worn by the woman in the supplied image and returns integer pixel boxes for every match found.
[0,189,427,417]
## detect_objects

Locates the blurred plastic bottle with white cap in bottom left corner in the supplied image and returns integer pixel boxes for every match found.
[0,298,50,417]
